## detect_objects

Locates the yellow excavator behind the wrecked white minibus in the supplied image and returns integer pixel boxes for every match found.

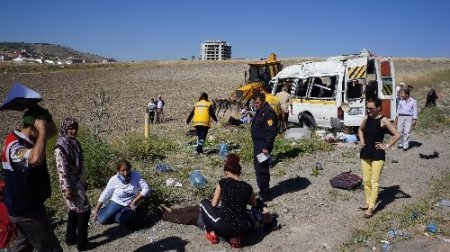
[235,53,283,105]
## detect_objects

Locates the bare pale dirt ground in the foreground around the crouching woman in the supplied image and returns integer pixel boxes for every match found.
[58,132,450,251]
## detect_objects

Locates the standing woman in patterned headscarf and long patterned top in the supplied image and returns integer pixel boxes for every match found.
[55,117,91,251]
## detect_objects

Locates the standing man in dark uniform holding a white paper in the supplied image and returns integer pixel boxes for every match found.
[251,93,278,201]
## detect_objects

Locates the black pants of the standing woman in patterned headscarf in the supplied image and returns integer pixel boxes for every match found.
[66,210,91,249]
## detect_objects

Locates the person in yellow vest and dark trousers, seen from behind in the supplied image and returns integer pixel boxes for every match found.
[186,93,217,156]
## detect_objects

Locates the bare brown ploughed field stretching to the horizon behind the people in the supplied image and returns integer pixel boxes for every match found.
[0,59,450,139]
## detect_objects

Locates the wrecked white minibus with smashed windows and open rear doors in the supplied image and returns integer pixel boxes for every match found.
[270,49,396,130]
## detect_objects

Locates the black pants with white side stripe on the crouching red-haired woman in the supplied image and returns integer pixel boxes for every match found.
[200,199,252,238]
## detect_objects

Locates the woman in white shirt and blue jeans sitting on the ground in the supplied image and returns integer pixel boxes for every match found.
[92,160,150,225]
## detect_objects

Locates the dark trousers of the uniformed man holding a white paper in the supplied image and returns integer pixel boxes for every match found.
[253,139,270,198]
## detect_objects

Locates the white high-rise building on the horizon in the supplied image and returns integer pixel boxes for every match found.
[200,40,231,60]
